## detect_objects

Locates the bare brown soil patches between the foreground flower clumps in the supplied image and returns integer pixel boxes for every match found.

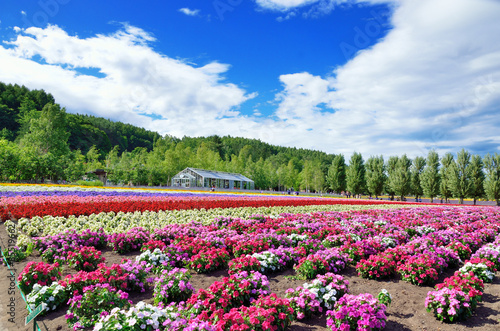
[0,225,500,331]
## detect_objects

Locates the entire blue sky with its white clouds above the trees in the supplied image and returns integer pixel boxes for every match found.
[0,0,500,157]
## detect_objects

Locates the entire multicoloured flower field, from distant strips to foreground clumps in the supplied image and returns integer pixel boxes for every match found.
[0,186,500,330]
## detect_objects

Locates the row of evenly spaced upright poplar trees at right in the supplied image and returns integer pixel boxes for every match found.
[326,149,500,206]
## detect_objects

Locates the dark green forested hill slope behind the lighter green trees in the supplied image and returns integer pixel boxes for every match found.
[0,82,333,163]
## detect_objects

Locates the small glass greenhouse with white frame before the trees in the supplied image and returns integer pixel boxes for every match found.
[172,168,255,190]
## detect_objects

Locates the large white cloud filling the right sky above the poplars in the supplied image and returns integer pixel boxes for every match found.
[270,0,500,155]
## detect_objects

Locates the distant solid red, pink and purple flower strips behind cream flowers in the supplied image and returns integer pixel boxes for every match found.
[0,186,414,221]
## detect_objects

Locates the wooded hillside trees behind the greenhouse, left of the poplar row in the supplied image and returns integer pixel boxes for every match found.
[0,83,333,189]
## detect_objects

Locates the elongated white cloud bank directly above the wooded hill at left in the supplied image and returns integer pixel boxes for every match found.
[0,25,254,136]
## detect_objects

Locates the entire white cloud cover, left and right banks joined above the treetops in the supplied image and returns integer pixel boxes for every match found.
[0,0,500,157]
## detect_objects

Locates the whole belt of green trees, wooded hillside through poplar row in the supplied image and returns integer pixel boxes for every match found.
[0,83,500,204]
